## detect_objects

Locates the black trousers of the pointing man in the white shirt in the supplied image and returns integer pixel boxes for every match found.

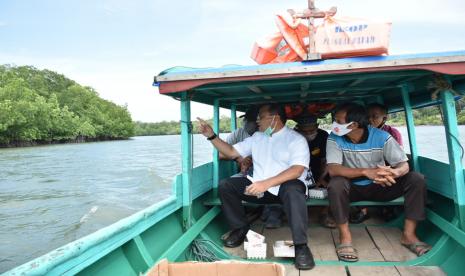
[218,177,308,244]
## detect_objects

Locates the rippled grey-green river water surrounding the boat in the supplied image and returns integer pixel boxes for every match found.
[0,126,465,273]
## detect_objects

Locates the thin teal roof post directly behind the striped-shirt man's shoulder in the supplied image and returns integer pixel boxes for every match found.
[401,85,420,172]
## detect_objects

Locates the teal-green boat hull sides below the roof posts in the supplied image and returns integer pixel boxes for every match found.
[6,157,465,275]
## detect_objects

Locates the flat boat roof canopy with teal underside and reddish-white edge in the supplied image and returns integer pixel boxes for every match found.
[154,51,465,112]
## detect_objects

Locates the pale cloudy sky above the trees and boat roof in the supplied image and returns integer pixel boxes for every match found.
[0,0,465,122]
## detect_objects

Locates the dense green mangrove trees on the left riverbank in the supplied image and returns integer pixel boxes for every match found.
[0,65,134,145]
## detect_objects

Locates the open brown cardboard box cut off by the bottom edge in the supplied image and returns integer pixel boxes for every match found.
[146,259,284,276]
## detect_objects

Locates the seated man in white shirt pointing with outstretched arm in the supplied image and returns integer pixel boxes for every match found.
[199,104,315,270]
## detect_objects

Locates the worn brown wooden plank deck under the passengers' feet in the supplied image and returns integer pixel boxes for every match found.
[225,208,445,276]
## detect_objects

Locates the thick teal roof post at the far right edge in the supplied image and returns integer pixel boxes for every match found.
[441,90,465,229]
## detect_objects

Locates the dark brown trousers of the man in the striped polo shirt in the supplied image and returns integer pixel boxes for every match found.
[328,172,426,224]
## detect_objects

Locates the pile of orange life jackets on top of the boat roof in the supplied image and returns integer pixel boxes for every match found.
[251,14,391,64]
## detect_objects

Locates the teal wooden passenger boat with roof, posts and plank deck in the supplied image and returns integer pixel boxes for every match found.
[6,51,465,275]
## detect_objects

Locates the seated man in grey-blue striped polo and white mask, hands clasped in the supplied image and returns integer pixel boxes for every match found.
[326,103,431,262]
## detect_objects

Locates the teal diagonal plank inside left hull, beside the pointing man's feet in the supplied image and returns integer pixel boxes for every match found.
[157,207,221,262]
